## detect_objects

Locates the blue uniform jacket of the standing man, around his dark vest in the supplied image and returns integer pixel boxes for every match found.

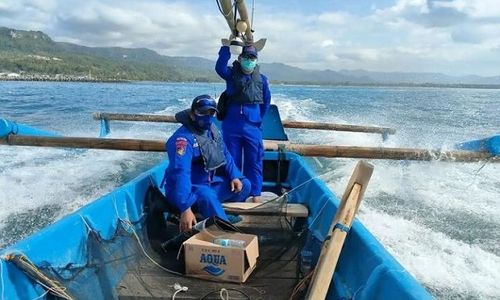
[215,46,271,125]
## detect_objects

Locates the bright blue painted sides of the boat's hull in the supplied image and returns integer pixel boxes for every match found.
[0,152,431,299]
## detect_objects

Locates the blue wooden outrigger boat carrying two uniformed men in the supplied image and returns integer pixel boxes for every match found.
[0,108,499,299]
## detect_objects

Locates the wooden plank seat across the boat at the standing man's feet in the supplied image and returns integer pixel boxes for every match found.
[223,202,309,218]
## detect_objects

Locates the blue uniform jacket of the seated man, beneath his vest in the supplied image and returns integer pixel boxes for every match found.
[165,125,243,212]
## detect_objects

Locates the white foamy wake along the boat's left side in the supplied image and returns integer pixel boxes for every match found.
[0,108,175,243]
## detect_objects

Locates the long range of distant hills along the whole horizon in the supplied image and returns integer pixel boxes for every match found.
[0,27,500,86]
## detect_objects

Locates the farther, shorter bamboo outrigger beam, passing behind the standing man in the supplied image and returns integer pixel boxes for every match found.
[93,112,396,134]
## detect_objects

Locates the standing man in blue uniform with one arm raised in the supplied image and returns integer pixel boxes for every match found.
[215,45,271,202]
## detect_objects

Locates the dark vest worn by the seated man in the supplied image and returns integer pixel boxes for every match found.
[175,109,226,171]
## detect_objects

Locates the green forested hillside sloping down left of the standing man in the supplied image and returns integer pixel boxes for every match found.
[0,27,218,81]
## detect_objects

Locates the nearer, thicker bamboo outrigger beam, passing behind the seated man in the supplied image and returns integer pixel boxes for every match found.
[0,134,500,162]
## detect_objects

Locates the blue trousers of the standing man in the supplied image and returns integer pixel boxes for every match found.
[222,120,264,196]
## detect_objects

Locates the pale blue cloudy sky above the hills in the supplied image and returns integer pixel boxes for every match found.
[0,0,500,76]
